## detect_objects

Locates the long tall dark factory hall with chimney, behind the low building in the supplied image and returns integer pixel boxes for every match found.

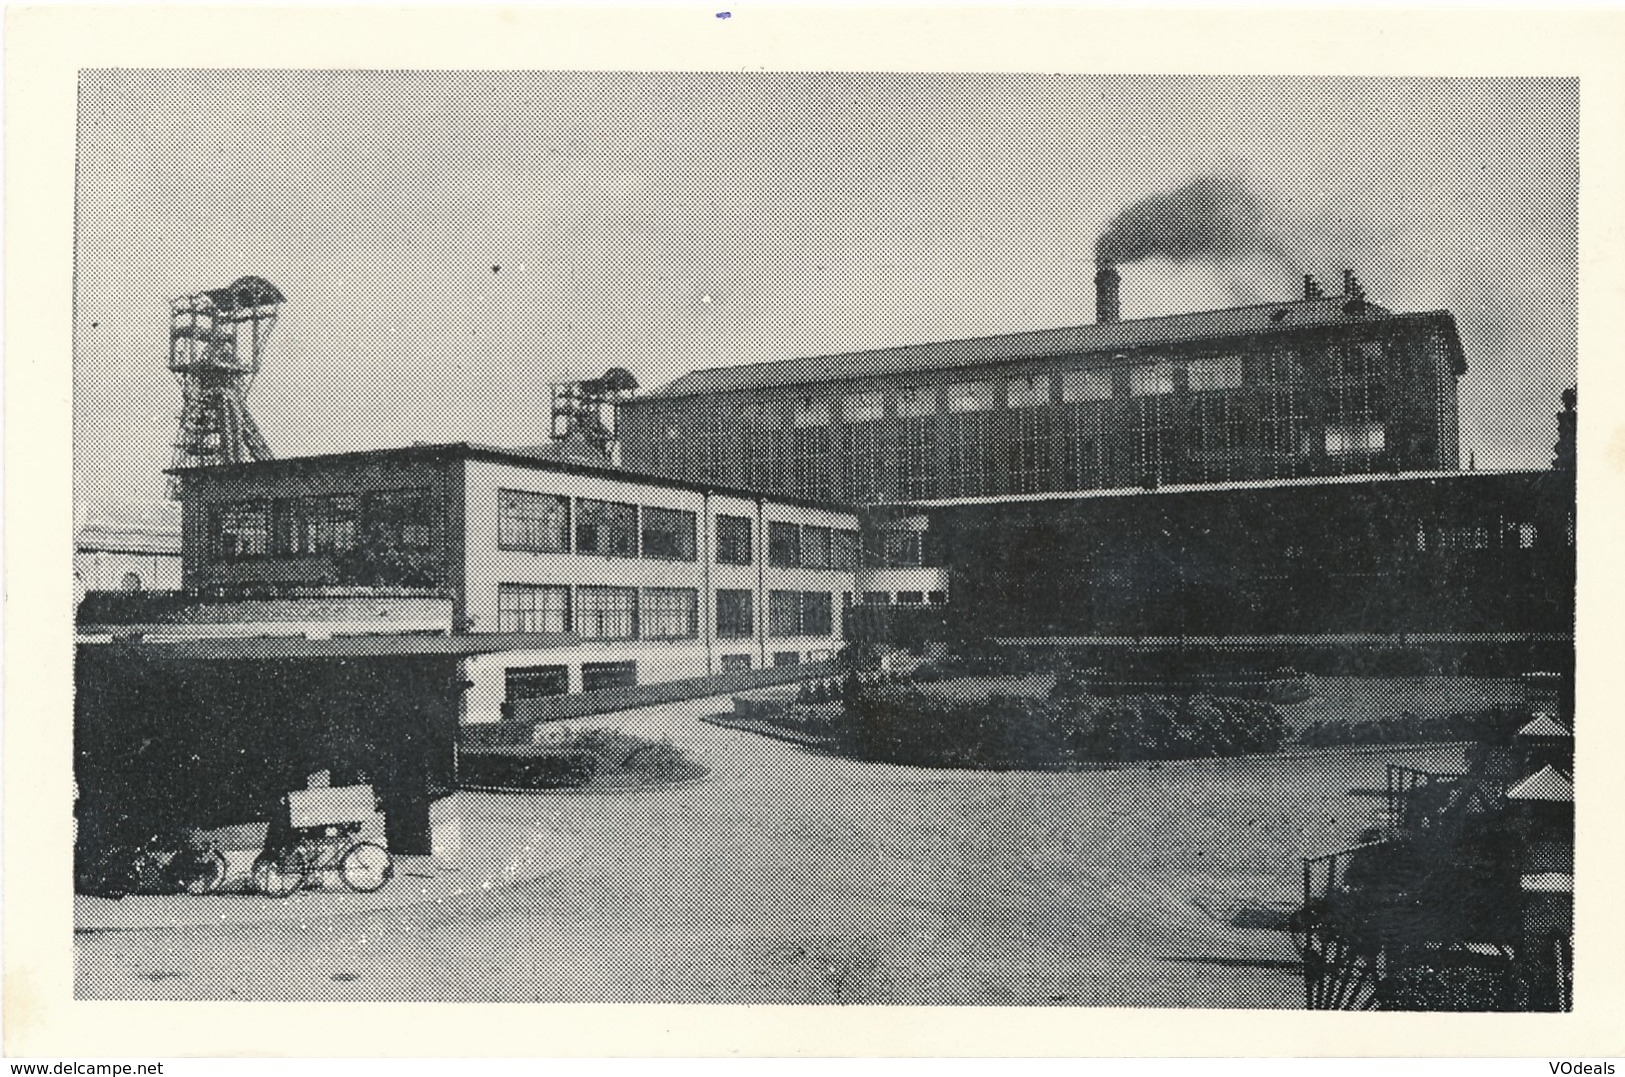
[619,266,1466,505]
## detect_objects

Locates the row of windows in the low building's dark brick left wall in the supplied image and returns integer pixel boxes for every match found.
[210,489,434,560]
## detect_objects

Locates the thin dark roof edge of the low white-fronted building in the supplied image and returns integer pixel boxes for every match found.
[166,442,853,512]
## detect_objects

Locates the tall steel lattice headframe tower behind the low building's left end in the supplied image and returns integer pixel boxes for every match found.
[169,276,283,495]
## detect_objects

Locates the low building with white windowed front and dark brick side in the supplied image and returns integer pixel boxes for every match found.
[163,443,858,721]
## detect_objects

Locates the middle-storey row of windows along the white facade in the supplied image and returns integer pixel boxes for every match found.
[497,583,835,640]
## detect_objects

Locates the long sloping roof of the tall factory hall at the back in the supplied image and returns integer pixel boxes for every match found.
[629,296,1466,406]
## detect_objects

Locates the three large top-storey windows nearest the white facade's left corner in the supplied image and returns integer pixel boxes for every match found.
[497,491,696,560]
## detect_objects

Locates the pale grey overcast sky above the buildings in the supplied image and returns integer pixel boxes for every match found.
[75,71,1578,499]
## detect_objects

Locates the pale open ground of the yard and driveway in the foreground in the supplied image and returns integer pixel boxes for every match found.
[75,700,1461,1007]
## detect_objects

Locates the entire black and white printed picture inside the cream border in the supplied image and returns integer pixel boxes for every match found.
[11,4,1610,1059]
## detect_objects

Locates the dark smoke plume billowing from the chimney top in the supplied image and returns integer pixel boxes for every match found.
[1095,174,1287,265]
